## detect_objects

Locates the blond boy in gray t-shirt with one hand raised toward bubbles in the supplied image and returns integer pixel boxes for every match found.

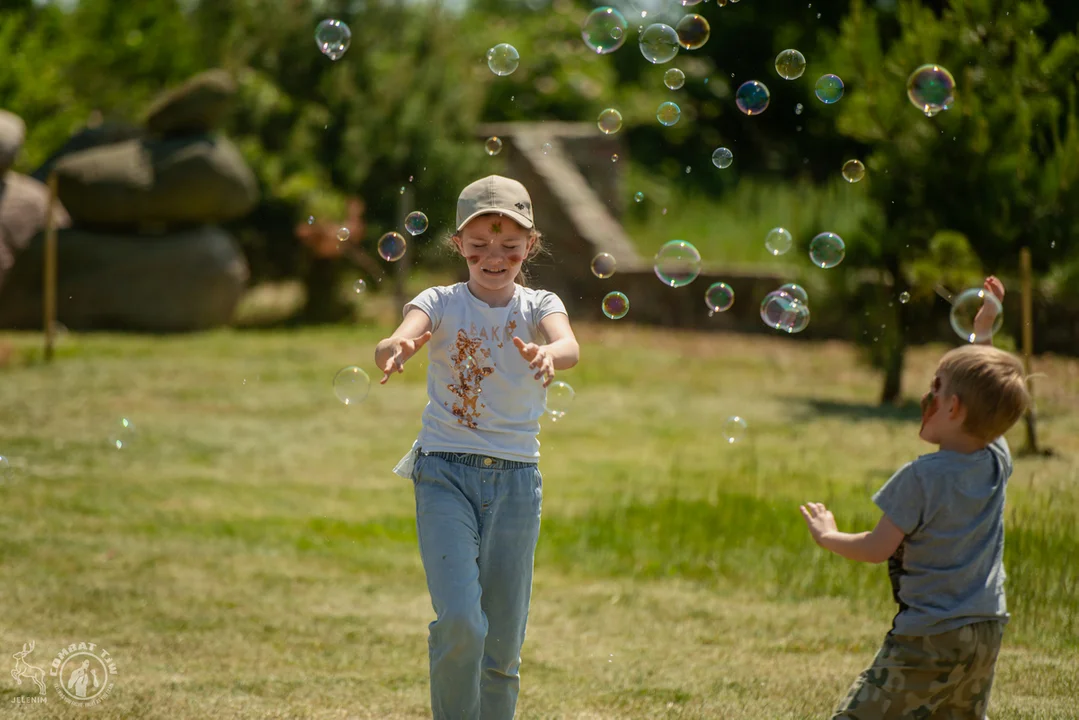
[801,276,1030,720]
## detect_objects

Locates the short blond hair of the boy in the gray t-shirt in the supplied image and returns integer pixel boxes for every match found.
[937,344,1030,443]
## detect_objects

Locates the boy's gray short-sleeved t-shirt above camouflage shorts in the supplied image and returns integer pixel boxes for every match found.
[873,437,1012,635]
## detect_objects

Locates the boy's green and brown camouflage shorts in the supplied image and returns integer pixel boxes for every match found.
[832,621,1003,720]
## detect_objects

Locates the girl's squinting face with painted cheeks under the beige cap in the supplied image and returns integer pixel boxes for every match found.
[453,215,534,290]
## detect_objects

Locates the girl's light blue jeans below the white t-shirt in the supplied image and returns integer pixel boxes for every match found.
[412,451,543,720]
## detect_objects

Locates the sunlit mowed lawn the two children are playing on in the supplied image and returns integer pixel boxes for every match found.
[0,317,1079,720]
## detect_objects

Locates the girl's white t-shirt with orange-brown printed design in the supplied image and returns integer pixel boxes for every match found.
[404,283,565,462]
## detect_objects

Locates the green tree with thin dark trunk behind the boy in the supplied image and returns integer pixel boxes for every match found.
[833,0,1079,403]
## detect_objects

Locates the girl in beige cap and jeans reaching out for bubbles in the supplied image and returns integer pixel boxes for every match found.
[374,175,579,720]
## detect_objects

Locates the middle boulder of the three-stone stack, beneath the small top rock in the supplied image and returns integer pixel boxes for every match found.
[54,135,259,231]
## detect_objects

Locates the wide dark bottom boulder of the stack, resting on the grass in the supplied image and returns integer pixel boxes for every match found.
[0,226,248,332]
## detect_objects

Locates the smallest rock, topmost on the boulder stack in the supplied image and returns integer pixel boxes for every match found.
[146,69,236,135]
